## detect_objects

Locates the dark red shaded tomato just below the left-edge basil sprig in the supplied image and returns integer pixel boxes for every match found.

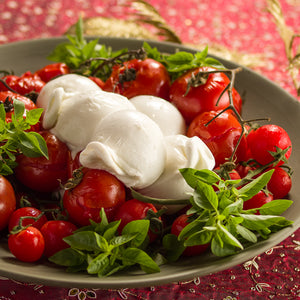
[15,131,69,192]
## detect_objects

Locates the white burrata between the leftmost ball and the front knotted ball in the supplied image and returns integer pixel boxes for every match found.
[49,90,135,156]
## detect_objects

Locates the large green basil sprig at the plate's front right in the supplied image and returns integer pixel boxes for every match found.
[163,168,293,261]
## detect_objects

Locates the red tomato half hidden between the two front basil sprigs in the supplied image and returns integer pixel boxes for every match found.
[114,199,159,242]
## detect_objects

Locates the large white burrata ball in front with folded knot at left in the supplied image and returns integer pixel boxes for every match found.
[80,110,166,189]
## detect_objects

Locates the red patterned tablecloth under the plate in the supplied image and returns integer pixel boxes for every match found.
[0,0,300,300]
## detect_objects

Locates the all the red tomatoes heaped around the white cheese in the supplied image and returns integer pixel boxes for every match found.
[0,54,292,262]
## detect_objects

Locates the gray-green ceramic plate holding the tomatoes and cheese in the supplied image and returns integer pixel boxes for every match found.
[0,38,300,288]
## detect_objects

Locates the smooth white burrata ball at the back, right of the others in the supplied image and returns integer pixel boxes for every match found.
[130,95,186,136]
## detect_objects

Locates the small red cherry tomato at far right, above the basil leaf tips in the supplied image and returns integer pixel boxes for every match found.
[267,167,292,199]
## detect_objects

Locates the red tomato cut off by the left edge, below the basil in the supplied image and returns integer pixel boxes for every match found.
[0,175,16,231]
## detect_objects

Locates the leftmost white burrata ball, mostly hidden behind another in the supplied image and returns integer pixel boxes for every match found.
[36,74,101,109]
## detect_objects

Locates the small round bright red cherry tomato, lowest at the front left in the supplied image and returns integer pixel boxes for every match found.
[8,226,45,262]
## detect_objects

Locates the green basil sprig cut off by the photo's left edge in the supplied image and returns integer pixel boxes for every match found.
[0,99,48,175]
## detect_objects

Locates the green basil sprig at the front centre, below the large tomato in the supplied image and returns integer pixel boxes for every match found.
[49,209,160,277]
